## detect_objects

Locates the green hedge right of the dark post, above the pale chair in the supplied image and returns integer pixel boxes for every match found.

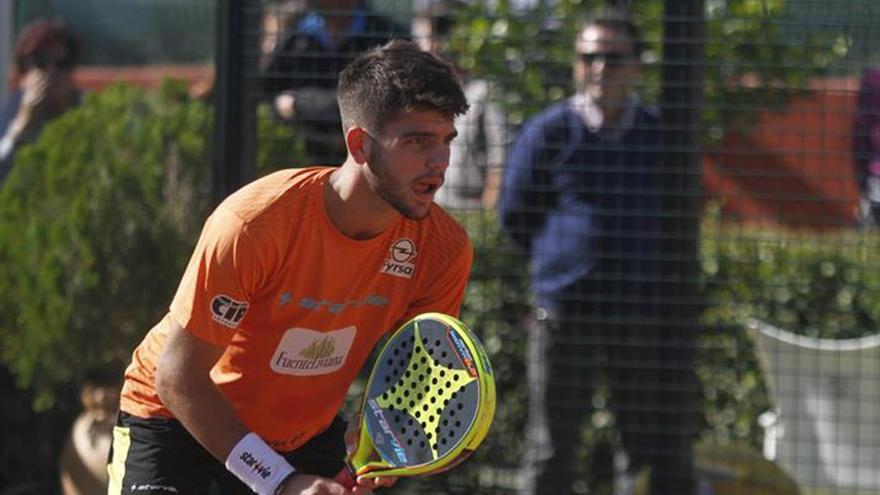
[702,207,880,339]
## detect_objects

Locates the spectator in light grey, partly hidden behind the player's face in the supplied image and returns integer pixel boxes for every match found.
[412,0,508,209]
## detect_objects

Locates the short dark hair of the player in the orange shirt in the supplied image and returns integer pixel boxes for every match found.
[337,40,468,132]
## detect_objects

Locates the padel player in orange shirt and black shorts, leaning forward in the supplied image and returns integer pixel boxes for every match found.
[108,41,473,495]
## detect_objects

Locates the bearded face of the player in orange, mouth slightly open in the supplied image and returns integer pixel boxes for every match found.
[367,111,457,220]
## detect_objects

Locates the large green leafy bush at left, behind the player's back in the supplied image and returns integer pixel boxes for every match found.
[0,81,296,409]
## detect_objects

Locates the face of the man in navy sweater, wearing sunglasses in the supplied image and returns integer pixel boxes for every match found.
[575,25,641,110]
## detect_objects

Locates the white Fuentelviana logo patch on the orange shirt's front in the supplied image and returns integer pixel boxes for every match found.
[270,325,357,376]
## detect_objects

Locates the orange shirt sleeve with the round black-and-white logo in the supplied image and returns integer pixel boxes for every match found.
[171,205,266,347]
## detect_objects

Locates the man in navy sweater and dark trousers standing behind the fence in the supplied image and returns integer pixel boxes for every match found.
[499,10,695,495]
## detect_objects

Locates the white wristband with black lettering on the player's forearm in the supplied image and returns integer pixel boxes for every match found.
[225,433,294,495]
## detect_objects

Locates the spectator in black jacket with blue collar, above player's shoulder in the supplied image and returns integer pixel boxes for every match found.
[263,0,408,164]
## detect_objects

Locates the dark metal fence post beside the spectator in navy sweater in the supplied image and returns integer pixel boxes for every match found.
[658,0,705,493]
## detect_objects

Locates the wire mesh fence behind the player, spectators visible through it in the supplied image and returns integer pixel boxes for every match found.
[0,0,880,495]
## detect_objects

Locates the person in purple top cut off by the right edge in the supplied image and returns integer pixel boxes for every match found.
[853,69,880,228]
